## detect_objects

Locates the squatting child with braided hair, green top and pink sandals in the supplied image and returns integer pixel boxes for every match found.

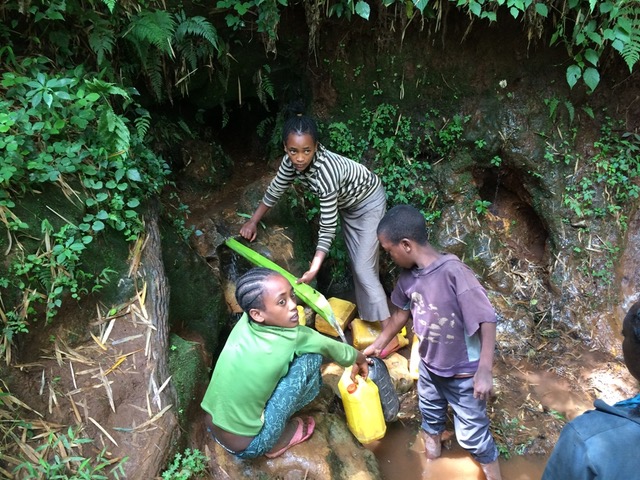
[201,268,368,458]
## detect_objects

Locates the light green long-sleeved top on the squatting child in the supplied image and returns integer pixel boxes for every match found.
[201,313,358,436]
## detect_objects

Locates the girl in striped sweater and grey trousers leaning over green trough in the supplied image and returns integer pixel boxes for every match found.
[240,108,398,356]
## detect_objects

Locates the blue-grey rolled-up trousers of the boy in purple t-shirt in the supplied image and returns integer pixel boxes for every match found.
[418,362,498,464]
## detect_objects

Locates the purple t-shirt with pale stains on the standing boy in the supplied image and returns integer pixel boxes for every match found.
[391,254,496,377]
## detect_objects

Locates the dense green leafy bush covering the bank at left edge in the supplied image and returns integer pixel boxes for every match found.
[0,57,169,353]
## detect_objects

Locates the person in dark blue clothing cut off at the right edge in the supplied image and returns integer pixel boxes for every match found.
[542,301,640,480]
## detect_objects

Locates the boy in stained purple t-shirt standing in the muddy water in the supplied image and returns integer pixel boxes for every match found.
[363,205,502,480]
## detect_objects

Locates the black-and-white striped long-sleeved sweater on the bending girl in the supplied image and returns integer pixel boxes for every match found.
[262,144,382,253]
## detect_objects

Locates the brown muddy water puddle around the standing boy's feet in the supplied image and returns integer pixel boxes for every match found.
[367,422,547,480]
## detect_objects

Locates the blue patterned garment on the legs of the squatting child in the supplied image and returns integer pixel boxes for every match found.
[231,353,322,458]
